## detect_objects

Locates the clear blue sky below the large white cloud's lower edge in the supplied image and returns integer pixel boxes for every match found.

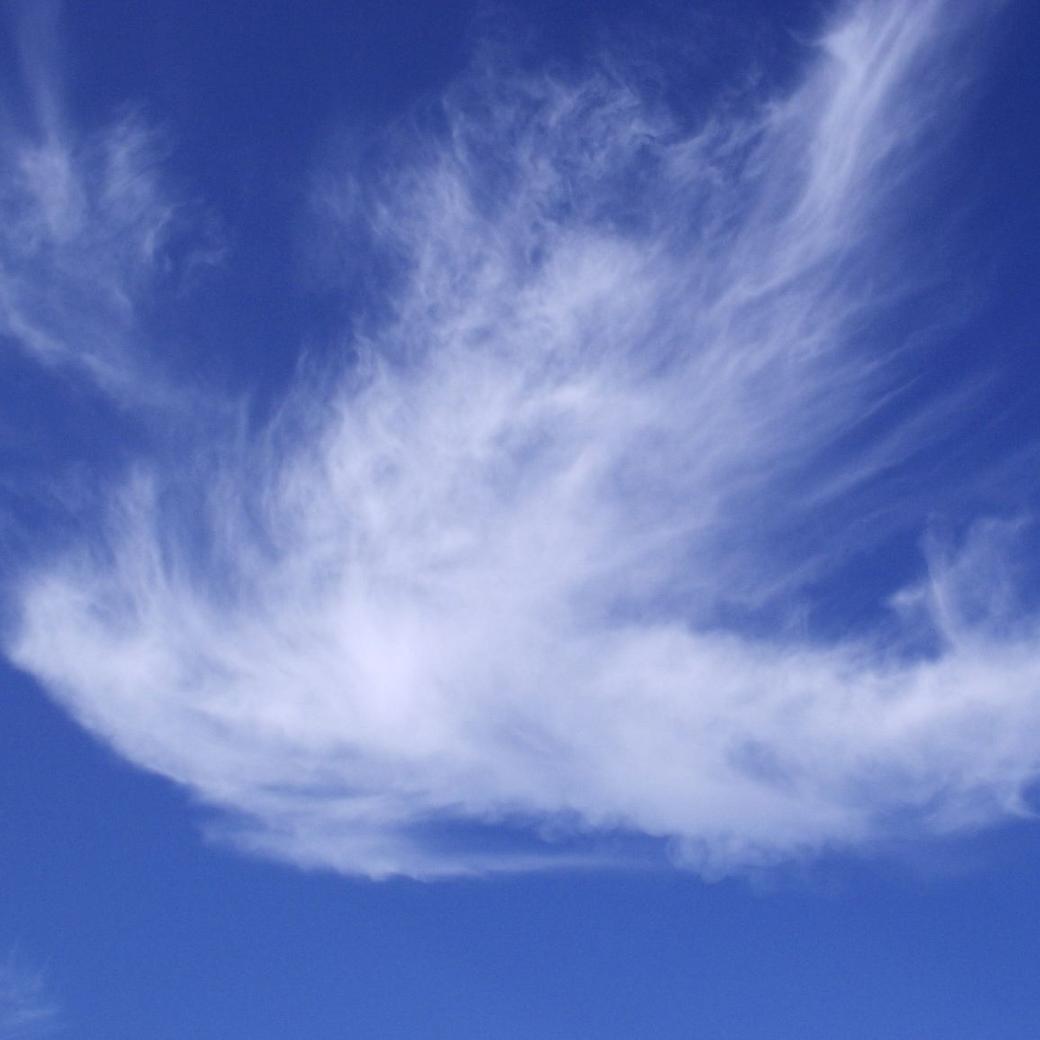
[6,673,1040,1040]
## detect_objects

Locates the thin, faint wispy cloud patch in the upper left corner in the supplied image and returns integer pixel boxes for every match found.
[0,0,219,404]
